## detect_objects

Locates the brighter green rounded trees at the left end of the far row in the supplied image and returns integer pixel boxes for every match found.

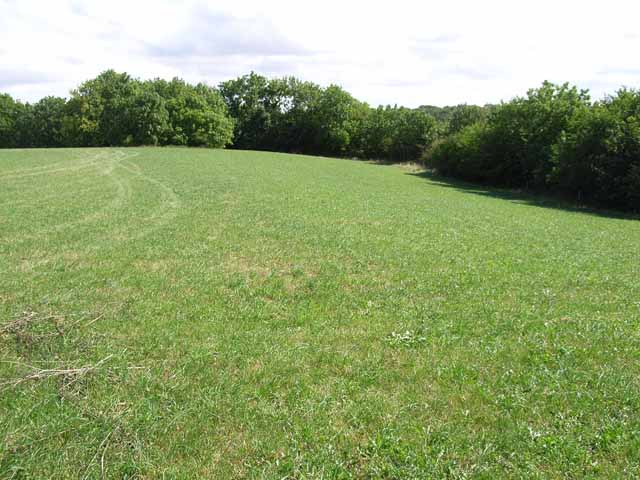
[0,70,233,148]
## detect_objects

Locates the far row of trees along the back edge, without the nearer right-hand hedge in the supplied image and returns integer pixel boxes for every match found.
[0,70,438,161]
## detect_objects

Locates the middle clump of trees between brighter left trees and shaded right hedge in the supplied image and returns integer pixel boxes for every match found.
[220,73,438,161]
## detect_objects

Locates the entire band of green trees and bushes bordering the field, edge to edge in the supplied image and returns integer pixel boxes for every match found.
[0,70,640,210]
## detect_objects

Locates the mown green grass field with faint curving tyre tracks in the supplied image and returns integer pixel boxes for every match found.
[0,148,640,479]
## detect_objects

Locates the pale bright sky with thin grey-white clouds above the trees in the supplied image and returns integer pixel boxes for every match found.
[0,0,640,107]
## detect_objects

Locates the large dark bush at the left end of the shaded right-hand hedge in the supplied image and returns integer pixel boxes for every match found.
[427,82,589,188]
